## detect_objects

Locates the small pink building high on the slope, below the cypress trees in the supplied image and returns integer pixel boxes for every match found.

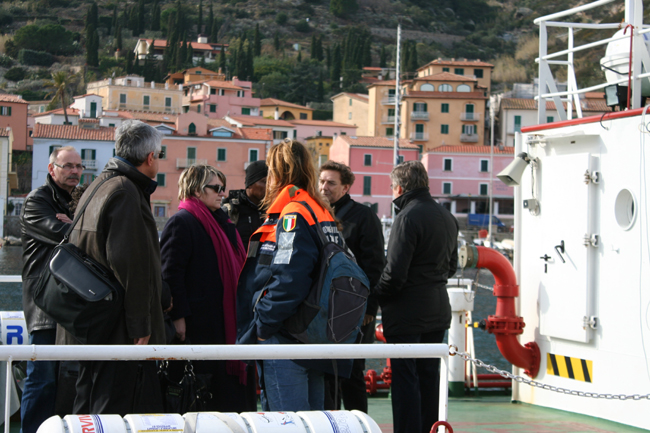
[182,77,260,119]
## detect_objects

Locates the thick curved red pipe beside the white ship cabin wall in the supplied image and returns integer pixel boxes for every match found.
[460,245,540,378]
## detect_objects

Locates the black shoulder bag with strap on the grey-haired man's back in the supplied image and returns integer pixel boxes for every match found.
[34,176,124,344]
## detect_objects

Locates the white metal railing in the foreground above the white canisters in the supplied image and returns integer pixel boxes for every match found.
[0,344,449,433]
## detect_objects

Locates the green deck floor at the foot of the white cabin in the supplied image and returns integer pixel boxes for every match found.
[368,396,647,433]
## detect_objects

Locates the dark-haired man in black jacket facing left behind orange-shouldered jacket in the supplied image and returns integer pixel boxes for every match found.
[319,161,385,413]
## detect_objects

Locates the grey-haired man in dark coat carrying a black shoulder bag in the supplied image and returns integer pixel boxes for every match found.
[57,121,165,416]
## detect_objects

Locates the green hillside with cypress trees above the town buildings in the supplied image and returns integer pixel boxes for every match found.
[0,0,648,107]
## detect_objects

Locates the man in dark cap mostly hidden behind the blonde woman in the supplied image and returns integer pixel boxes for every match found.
[222,160,269,247]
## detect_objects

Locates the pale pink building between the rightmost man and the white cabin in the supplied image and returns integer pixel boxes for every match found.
[422,146,514,226]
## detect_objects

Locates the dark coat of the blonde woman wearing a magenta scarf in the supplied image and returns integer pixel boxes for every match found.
[160,210,237,344]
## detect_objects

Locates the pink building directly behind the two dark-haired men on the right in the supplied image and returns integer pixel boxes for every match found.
[330,135,420,217]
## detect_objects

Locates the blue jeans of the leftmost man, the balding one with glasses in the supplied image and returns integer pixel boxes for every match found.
[20,329,58,433]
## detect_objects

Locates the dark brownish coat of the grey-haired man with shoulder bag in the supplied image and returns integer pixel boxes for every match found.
[58,158,165,344]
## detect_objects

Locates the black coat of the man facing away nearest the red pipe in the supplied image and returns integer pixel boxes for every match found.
[375,188,458,336]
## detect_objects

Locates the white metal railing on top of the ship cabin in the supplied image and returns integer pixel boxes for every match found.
[534,0,650,124]
